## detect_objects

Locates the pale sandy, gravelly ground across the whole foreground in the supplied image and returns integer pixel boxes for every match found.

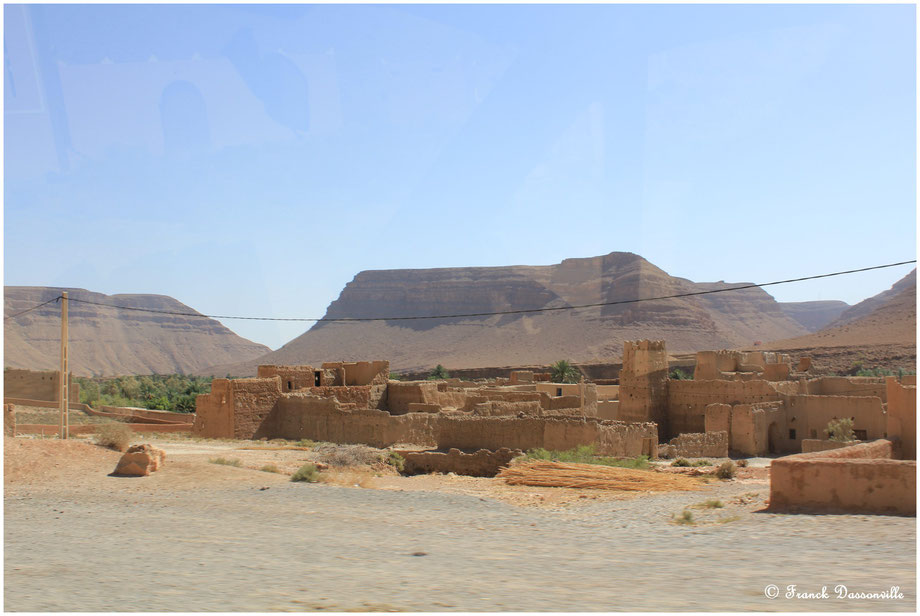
[4,438,916,611]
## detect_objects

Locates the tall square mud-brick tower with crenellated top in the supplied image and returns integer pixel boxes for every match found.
[619,340,672,438]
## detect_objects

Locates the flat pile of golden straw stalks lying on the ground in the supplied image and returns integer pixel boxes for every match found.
[498,460,700,492]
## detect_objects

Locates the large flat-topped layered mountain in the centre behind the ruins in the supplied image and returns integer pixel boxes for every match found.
[213,252,807,376]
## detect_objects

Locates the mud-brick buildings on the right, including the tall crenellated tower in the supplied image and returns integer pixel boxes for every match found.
[598,340,916,458]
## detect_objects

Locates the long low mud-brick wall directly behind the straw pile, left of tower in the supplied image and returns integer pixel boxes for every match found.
[436,416,658,457]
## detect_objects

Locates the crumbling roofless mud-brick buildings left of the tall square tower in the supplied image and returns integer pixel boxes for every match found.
[193,361,658,457]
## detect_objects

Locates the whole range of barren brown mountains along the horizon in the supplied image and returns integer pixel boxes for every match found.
[4,252,916,376]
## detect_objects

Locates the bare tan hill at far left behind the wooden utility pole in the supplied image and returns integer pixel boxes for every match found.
[3,287,270,375]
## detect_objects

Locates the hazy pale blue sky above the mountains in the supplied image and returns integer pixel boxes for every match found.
[4,5,916,348]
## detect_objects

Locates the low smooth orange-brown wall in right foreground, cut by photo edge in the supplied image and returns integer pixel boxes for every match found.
[770,440,917,515]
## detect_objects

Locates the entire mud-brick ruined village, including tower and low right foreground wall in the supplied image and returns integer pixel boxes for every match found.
[193,340,916,513]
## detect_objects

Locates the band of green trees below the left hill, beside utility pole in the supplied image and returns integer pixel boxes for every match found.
[74,374,212,413]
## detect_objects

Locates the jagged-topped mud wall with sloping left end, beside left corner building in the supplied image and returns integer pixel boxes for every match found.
[254,392,439,447]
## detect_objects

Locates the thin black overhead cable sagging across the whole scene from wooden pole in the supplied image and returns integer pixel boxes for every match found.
[6,259,917,323]
